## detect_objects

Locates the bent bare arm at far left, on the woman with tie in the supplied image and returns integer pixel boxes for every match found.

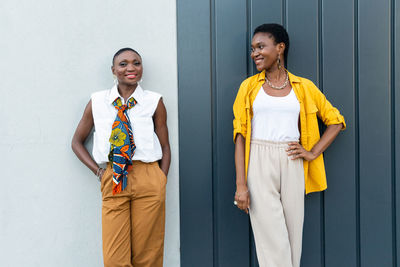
[71,101,99,174]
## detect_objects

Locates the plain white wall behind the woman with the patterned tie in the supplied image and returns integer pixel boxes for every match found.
[0,0,179,267]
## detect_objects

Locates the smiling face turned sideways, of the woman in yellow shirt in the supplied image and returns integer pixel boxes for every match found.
[251,32,285,71]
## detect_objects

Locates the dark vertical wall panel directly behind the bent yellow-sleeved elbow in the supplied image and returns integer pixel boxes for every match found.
[322,0,357,267]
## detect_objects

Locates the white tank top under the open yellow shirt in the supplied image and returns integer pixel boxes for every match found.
[251,87,300,142]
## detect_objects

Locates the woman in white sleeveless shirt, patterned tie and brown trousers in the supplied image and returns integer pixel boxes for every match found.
[72,48,171,267]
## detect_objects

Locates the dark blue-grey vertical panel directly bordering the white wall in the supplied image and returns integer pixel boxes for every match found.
[177,1,213,267]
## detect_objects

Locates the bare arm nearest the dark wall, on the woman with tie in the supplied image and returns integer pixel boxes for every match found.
[153,98,171,175]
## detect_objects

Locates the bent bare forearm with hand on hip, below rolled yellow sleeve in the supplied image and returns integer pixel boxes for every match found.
[287,123,343,161]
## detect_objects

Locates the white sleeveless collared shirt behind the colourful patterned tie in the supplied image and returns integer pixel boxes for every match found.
[91,85,162,164]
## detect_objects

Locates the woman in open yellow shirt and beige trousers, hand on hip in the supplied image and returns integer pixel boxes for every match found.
[233,24,346,267]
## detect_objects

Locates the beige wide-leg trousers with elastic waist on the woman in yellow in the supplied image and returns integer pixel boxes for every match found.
[247,140,304,267]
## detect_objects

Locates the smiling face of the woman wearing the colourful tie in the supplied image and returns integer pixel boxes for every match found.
[111,51,143,86]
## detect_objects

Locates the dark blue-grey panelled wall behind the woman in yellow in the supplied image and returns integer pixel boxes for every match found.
[177,0,400,267]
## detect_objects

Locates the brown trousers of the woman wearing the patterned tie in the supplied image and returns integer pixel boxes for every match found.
[101,161,167,267]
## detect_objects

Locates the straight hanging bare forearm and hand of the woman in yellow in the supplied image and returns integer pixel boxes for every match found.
[235,134,250,213]
